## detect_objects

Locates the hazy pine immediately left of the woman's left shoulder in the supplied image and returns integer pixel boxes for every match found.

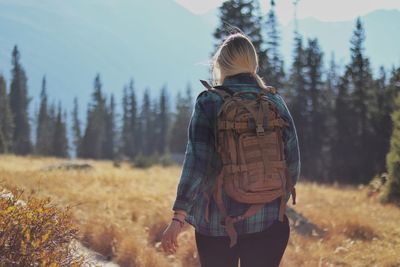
[169,85,193,154]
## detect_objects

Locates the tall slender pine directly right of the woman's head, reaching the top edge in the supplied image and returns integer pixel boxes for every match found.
[265,0,285,88]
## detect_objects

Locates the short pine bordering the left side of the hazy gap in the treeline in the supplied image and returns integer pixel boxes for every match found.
[52,103,68,158]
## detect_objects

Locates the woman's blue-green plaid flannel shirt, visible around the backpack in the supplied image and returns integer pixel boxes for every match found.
[172,74,300,236]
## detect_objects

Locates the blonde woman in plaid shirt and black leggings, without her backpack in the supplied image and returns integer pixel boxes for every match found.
[162,33,300,267]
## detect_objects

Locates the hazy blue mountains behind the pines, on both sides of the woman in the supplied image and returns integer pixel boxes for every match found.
[0,0,400,117]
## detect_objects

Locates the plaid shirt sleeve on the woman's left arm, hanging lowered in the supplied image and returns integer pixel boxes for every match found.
[172,96,215,212]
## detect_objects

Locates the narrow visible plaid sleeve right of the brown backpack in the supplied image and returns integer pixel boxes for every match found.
[279,96,300,184]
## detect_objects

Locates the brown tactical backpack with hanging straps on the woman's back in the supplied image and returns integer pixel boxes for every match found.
[202,81,296,247]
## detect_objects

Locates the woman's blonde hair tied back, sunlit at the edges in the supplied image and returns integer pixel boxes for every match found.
[211,33,266,88]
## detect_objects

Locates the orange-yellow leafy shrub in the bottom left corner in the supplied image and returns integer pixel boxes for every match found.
[0,190,84,267]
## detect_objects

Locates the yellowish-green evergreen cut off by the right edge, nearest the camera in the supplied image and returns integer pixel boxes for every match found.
[385,94,400,204]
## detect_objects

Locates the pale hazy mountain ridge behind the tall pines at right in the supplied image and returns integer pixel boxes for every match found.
[281,10,400,71]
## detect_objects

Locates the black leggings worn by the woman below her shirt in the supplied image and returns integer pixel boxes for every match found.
[195,216,290,267]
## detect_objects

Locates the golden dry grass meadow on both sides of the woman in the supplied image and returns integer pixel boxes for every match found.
[0,155,400,267]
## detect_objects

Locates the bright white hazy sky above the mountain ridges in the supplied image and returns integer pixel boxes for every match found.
[174,0,400,24]
